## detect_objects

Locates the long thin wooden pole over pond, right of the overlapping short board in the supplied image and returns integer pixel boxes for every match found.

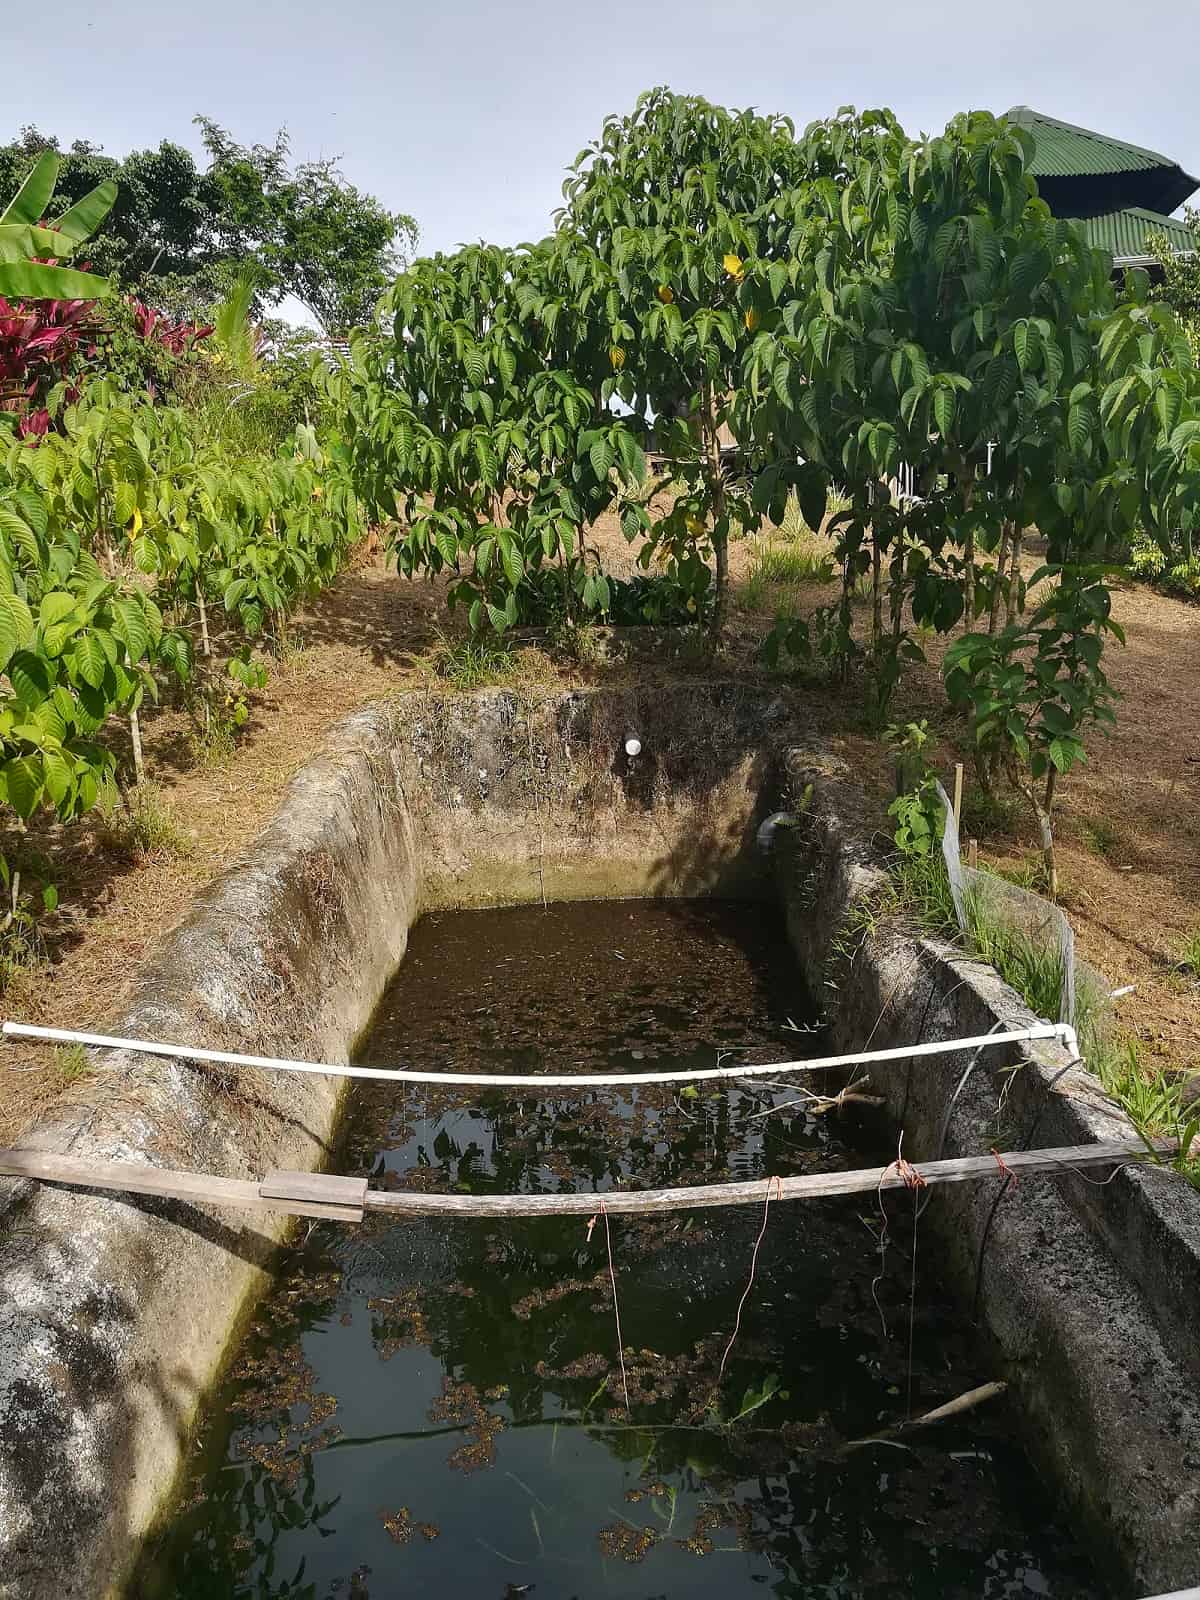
[366,1139,1176,1216]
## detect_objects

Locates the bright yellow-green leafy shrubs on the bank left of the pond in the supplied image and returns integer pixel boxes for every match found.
[0,382,360,819]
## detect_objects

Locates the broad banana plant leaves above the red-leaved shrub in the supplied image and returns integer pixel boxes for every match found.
[0,150,117,301]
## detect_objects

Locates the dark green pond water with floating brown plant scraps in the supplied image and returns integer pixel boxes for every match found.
[136,902,1107,1600]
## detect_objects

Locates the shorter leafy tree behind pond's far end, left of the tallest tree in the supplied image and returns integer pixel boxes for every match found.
[331,242,643,632]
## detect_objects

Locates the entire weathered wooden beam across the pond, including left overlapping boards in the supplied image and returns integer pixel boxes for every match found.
[0,1139,1179,1222]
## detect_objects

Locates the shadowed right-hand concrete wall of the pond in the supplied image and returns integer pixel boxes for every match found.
[779,752,1200,1592]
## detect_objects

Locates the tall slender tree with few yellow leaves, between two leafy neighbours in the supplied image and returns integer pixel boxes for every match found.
[555,88,812,640]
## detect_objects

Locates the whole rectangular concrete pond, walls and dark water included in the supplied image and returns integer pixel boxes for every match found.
[0,683,1200,1600]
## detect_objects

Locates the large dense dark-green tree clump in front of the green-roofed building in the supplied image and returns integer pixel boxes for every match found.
[749,112,1200,888]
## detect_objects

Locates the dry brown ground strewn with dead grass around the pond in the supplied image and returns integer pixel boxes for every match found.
[0,528,1200,1144]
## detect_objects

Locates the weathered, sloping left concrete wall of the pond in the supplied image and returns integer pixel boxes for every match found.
[0,710,419,1600]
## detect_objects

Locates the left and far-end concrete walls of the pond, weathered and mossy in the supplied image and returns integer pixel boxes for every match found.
[0,685,795,1600]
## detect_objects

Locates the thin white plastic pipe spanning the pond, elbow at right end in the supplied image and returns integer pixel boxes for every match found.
[3,1022,1078,1090]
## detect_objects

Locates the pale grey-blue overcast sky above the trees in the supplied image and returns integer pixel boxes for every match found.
[0,0,1200,264]
